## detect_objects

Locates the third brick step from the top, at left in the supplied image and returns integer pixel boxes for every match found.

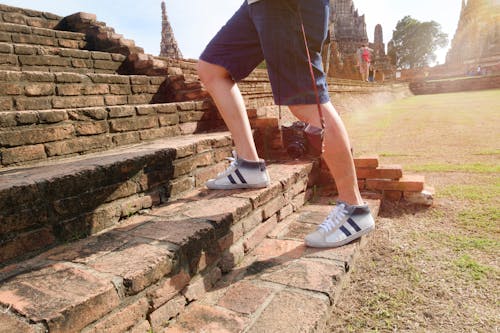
[0,43,126,74]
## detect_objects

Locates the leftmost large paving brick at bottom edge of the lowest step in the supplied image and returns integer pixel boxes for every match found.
[165,303,248,333]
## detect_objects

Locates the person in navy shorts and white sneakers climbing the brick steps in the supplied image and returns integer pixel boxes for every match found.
[198,0,375,247]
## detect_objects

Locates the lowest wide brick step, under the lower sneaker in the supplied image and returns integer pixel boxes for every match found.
[149,198,380,333]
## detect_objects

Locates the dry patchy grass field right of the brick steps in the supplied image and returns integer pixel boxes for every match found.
[329,90,500,332]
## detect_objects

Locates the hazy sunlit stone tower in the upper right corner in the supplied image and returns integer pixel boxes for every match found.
[446,0,500,70]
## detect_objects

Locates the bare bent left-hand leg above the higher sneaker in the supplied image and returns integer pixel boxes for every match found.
[198,60,259,161]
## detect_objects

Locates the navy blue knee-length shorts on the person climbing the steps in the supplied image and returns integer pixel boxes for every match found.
[200,0,330,105]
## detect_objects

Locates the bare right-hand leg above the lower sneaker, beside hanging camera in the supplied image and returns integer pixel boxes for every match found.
[290,102,363,205]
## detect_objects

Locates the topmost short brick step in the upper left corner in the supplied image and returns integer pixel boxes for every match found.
[0,4,62,29]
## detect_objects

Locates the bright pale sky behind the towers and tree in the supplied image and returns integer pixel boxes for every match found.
[0,0,462,63]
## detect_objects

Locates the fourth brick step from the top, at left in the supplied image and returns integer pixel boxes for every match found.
[0,70,169,111]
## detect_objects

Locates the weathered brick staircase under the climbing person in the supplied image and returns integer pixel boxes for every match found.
[0,5,432,332]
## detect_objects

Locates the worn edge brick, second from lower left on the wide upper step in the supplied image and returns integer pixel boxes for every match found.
[89,244,173,294]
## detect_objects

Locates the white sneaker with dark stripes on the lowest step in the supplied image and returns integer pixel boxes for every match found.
[305,201,375,247]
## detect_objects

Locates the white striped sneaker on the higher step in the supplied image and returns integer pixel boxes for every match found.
[206,151,270,190]
